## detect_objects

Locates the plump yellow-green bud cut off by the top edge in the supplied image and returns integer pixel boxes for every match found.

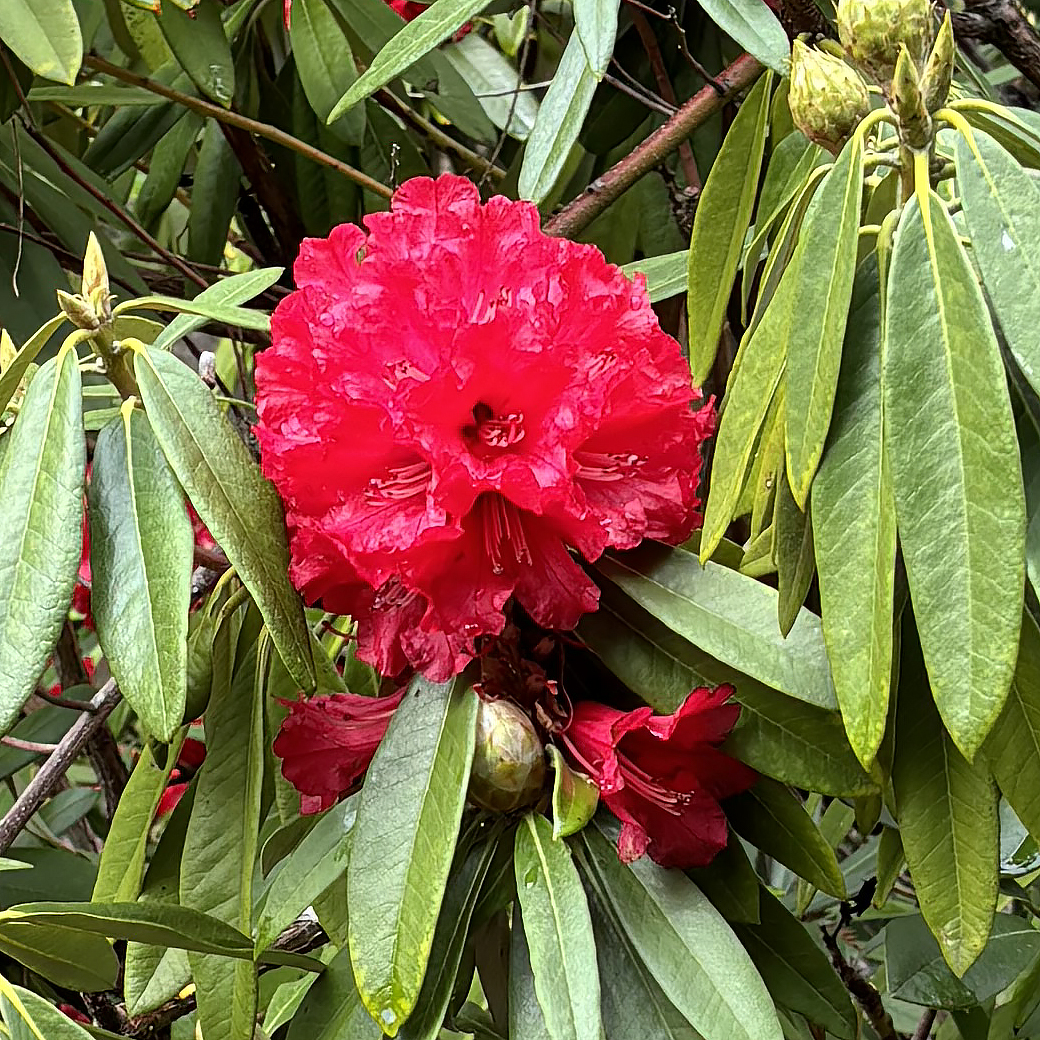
[837,0,935,93]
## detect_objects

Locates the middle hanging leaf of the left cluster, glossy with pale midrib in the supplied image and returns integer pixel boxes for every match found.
[87,406,194,742]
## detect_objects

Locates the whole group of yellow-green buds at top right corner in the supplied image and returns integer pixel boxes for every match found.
[788,0,956,155]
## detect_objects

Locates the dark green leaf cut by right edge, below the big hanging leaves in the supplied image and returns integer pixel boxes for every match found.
[983,614,1040,837]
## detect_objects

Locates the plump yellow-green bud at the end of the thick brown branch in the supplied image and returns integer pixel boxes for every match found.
[787,40,870,155]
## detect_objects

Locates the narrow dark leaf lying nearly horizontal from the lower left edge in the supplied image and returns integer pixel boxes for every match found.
[0,903,253,960]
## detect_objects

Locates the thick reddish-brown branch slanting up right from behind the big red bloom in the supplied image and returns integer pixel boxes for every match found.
[545,54,764,238]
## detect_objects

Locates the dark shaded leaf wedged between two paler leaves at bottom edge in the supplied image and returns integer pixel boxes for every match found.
[587,891,698,1040]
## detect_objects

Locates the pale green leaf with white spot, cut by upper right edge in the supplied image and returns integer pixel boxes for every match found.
[956,122,1040,390]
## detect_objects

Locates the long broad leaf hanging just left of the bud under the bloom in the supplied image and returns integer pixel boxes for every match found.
[346,677,477,1036]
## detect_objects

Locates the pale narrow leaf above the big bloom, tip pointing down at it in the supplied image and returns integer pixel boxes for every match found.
[517,32,597,204]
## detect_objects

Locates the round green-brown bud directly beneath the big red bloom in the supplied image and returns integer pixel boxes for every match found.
[469,699,545,812]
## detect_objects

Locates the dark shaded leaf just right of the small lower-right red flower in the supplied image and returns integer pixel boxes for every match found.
[726,778,848,900]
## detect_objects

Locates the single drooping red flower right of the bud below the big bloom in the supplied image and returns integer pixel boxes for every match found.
[561,685,756,868]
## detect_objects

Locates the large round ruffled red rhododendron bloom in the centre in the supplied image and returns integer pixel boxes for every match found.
[256,176,714,681]
